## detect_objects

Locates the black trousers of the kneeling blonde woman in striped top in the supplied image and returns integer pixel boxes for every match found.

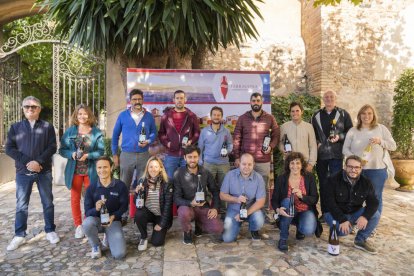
[135,207,168,246]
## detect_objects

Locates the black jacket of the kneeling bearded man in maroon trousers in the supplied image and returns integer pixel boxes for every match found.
[173,165,220,209]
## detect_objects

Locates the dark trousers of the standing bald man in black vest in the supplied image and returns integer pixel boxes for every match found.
[316,159,342,214]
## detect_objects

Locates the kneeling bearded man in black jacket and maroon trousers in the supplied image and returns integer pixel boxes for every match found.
[173,145,223,245]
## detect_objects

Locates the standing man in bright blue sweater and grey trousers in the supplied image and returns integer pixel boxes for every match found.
[112,89,157,190]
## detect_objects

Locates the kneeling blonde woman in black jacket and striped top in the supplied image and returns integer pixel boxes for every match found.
[133,156,173,251]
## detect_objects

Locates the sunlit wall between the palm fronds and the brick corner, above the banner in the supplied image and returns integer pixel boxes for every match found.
[205,0,306,95]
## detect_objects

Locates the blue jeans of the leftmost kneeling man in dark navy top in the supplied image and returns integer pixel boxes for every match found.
[82,217,127,259]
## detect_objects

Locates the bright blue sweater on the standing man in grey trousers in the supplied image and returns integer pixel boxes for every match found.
[112,109,157,154]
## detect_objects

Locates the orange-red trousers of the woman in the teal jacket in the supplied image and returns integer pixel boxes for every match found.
[70,174,89,226]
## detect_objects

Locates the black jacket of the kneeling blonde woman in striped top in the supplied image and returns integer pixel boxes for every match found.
[132,179,173,229]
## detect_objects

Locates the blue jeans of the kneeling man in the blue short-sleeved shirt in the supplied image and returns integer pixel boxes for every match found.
[223,209,264,242]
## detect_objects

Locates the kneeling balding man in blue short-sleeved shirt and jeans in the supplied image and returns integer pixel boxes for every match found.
[220,153,266,242]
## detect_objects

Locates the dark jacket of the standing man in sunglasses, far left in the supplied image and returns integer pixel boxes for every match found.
[6,119,57,174]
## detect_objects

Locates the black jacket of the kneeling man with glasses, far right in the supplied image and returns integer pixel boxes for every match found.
[326,170,379,223]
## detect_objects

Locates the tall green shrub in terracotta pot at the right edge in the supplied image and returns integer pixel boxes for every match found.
[392,68,414,192]
